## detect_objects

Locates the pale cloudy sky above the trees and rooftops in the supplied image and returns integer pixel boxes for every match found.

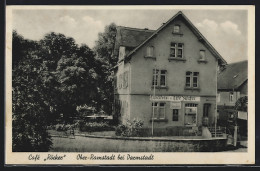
[12,9,248,63]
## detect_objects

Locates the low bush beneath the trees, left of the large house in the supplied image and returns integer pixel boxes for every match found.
[79,122,114,132]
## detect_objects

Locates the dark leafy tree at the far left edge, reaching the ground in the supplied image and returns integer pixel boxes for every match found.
[12,32,52,152]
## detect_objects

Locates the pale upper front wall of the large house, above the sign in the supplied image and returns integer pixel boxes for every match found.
[130,18,217,96]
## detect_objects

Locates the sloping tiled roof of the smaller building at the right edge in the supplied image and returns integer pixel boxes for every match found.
[218,60,248,90]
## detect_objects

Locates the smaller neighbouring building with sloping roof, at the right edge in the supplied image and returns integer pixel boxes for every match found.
[217,60,248,122]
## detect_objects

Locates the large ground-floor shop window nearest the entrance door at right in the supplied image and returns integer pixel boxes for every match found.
[184,103,197,126]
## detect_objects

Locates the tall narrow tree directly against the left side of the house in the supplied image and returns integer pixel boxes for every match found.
[94,23,118,114]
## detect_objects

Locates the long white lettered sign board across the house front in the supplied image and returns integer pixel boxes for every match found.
[150,95,200,102]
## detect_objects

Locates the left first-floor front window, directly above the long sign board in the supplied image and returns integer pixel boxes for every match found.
[152,69,166,87]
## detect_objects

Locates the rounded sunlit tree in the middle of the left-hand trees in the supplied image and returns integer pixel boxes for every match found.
[56,45,97,121]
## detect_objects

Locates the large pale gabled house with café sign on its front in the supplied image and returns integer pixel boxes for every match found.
[113,11,226,134]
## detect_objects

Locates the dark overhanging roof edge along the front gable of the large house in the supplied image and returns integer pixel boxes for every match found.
[119,11,227,65]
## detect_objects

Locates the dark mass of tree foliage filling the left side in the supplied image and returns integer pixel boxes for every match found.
[12,24,117,151]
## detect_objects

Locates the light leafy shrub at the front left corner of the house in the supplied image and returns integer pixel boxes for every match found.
[115,119,144,137]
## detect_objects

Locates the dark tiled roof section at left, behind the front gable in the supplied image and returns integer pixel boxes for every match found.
[114,26,154,55]
